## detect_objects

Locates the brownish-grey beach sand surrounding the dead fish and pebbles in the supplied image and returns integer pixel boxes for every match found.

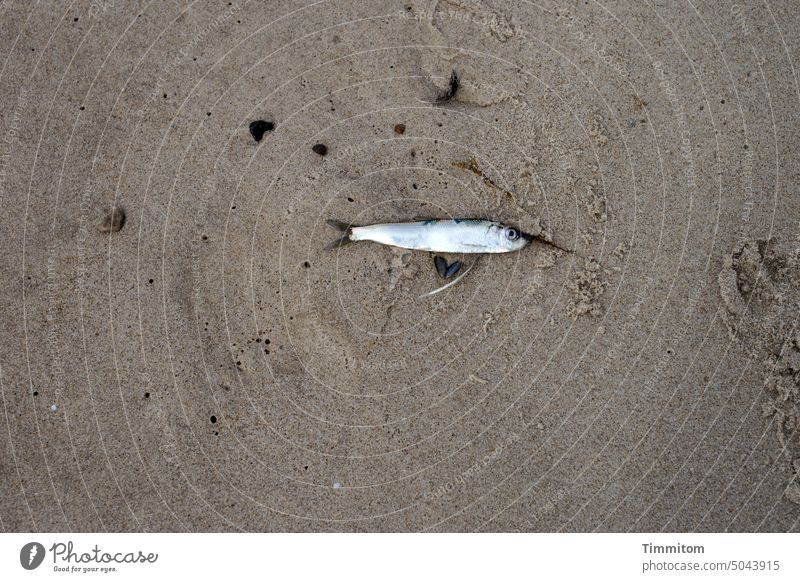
[0,0,800,531]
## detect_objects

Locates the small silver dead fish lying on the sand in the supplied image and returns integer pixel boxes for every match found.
[328,219,532,253]
